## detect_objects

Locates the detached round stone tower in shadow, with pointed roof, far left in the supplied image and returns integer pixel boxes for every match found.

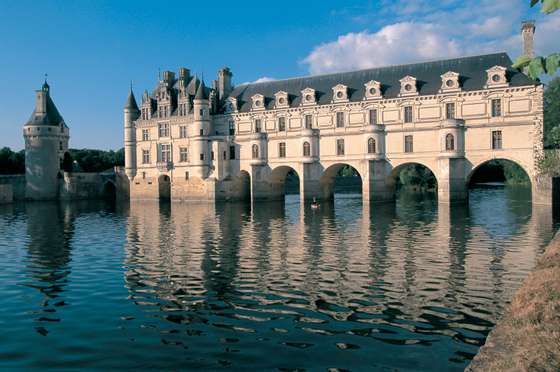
[23,80,70,200]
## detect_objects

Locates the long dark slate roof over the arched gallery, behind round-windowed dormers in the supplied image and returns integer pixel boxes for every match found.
[230,53,538,112]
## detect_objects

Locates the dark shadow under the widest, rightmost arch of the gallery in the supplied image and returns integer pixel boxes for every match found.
[467,158,531,188]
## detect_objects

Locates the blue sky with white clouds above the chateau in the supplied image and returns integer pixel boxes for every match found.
[0,0,560,149]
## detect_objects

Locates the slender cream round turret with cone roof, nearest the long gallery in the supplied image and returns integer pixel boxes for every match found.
[190,80,212,178]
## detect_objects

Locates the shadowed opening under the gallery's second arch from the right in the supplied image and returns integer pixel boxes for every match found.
[387,162,438,197]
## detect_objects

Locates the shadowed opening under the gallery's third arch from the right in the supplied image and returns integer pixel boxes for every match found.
[319,163,363,200]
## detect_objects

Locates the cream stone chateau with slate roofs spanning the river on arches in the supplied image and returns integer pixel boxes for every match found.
[124,22,550,204]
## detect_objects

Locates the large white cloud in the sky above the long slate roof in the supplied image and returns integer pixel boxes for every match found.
[300,0,560,74]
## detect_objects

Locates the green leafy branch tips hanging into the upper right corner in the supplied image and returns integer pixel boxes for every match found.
[513,0,560,79]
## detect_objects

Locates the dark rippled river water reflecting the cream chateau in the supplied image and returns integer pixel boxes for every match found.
[0,188,554,371]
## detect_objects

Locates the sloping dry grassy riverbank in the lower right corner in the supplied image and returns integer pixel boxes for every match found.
[466,233,560,372]
